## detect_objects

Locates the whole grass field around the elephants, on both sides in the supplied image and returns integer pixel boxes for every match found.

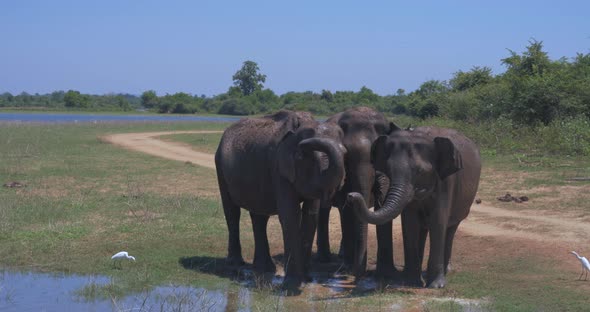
[0,123,590,311]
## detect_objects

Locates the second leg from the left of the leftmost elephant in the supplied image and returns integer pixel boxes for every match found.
[250,212,276,273]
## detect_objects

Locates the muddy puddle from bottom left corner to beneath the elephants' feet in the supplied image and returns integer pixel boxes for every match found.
[0,271,376,312]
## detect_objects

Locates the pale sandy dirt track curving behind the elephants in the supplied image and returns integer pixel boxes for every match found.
[102,131,590,242]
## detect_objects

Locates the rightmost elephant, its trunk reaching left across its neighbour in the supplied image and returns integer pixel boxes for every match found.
[347,127,481,288]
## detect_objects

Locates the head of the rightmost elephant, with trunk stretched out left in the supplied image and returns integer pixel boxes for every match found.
[347,130,463,224]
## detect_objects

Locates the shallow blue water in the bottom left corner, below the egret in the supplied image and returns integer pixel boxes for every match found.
[0,271,245,312]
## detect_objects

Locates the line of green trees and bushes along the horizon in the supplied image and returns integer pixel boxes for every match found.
[0,40,590,129]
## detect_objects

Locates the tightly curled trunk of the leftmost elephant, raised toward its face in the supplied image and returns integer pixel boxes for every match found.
[298,138,345,196]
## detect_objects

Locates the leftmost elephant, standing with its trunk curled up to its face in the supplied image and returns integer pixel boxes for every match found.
[215,110,346,289]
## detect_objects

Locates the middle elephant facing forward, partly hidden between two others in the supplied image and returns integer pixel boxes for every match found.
[317,107,397,277]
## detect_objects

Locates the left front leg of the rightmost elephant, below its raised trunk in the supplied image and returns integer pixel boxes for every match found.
[402,207,425,287]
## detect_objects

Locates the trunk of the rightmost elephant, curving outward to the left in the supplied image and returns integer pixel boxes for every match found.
[346,183,414,225]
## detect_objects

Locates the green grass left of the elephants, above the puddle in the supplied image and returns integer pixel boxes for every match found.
[0,123,234,284]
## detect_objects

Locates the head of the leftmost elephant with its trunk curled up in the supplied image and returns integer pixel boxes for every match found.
[277,121,346,199]
